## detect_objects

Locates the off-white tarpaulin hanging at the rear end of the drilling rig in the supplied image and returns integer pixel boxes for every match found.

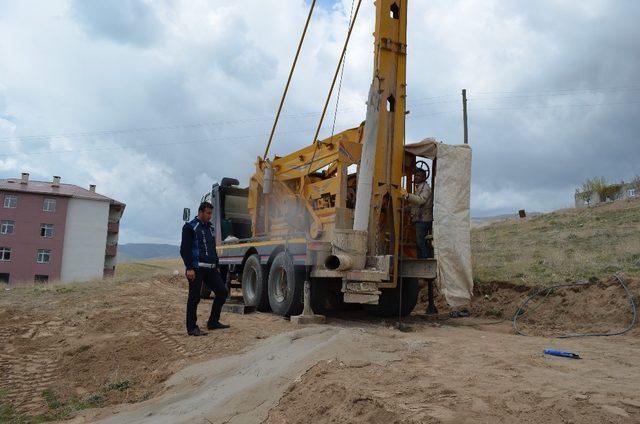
[406,139,473,307]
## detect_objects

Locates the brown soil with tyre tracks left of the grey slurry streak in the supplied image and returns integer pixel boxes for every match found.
[0,277,289,414]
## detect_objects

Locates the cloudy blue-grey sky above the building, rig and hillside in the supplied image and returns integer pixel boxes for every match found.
[0,0,640,243]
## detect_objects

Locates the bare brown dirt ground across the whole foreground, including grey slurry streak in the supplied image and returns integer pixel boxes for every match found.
[0,277,640,423]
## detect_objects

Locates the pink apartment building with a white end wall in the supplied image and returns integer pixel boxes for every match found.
[0,173,125,285]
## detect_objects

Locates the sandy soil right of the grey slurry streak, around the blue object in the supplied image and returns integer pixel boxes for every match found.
[267,325,640,423]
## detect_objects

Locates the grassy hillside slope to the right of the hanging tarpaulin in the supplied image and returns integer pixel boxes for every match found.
[471,200,640,283]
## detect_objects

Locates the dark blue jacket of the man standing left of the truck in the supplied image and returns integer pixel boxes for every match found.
[180,218,218,269]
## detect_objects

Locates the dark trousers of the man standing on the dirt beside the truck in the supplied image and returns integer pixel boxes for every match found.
[187,268,229,331]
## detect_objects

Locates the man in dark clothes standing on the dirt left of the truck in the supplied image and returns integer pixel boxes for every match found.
[180,202,229,336]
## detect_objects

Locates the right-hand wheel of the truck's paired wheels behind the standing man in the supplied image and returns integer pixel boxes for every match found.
[269,252,304,316]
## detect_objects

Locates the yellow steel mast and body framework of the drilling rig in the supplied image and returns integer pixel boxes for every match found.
[249,0,407,283]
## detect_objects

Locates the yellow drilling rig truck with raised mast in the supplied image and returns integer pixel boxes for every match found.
[188,0,470,316]
